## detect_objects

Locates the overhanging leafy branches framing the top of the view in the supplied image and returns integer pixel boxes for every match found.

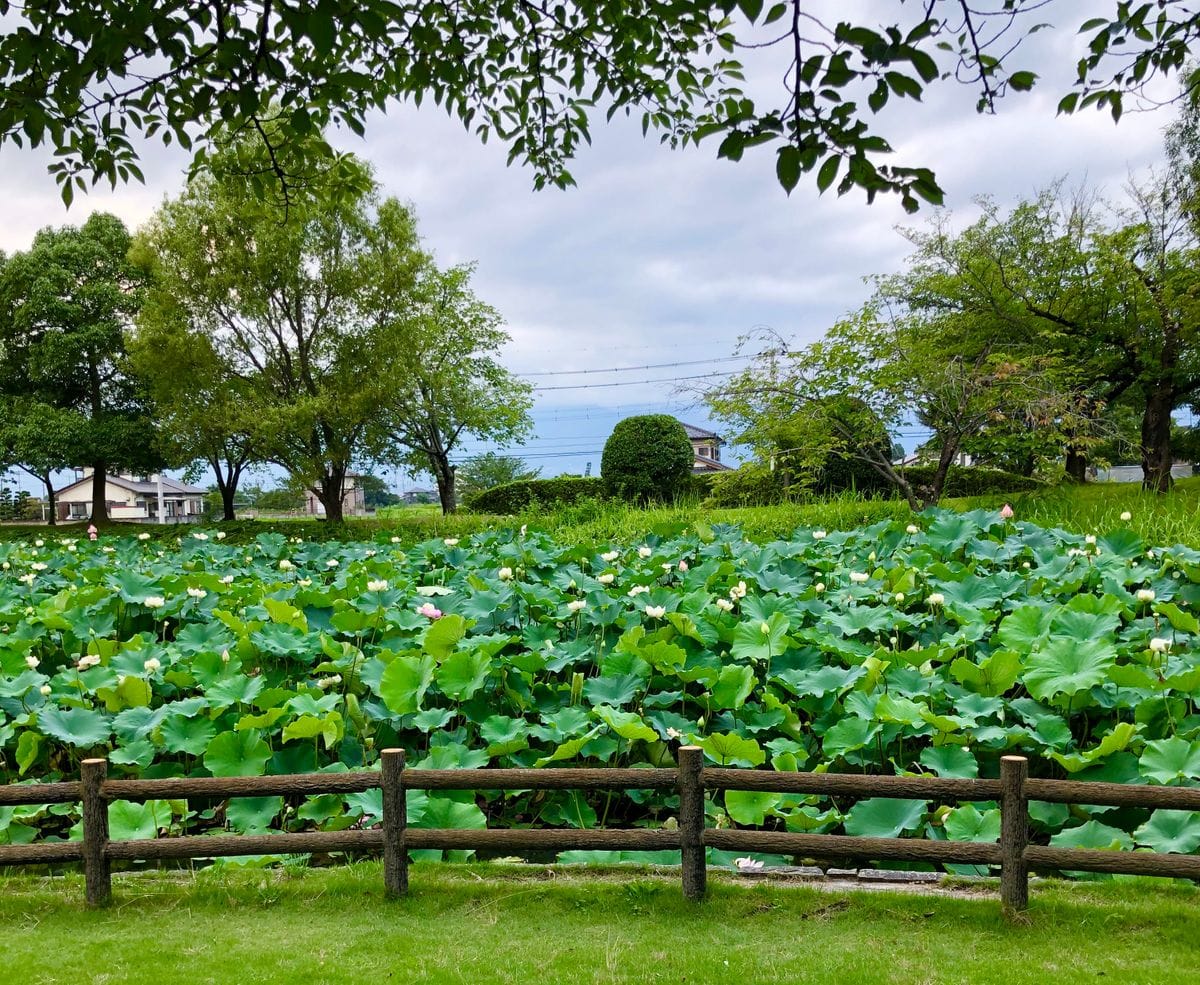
[0,0,1200,209]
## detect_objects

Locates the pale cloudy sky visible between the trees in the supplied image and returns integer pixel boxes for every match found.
[0,0,1170,487]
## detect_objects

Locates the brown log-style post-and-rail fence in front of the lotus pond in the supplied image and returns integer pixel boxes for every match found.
[0,746,1200,913]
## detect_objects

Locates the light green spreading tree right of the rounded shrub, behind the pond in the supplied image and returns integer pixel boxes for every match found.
[707,321,1060,510]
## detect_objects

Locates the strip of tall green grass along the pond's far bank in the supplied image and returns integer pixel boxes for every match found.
[7,478,1200,548]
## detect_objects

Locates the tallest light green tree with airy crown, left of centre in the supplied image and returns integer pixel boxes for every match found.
[132,137,428,522]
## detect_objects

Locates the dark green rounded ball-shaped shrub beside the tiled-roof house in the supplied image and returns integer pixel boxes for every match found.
[600,414,695,503]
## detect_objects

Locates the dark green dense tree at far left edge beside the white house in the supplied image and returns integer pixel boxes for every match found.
[0,212,161,523]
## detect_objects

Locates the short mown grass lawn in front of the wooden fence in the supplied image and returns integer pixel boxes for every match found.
[0,863,1200,985]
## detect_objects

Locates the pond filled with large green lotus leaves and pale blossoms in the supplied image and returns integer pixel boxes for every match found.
[0,511,1200,861]
